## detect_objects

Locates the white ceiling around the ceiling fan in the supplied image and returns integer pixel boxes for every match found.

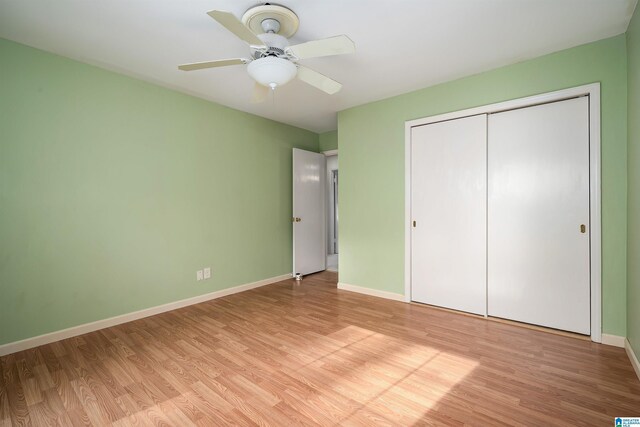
[0,0,637,132]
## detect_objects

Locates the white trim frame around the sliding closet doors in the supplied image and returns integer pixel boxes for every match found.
[404,83,602,342]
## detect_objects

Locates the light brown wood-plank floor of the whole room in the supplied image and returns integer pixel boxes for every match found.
[0,272,640,426]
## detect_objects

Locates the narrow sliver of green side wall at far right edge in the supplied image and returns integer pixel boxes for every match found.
[627,7,640,359]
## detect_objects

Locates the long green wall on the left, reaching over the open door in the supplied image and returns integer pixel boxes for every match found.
[0,40,318,344]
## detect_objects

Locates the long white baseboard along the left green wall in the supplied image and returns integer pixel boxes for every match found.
[0,274,291,356]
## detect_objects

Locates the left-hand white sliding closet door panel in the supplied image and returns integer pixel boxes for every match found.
[411,115,487,314]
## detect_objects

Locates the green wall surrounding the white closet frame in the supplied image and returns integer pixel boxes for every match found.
[338,35,627,336]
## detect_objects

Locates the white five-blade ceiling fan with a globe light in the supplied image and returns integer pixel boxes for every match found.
[178,3,355,102]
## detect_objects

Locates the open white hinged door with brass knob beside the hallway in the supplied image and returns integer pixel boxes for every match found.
[293,148,327,275]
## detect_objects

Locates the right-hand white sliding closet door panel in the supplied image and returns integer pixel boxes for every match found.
[487,97,591,334]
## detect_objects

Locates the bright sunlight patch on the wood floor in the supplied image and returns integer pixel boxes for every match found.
[298,325,479,425]
